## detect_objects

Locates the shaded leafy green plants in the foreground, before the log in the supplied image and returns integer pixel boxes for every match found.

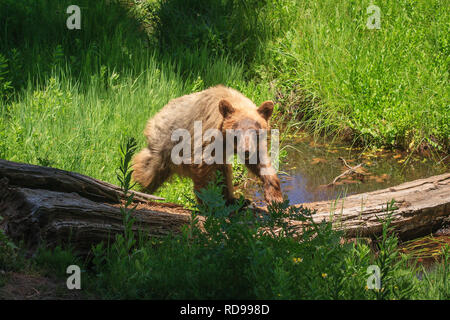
[0,135,450,300]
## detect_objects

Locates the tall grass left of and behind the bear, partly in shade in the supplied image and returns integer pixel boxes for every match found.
[0,0,276,202]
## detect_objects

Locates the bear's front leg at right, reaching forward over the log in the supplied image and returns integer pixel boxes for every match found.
[247,164,283,203]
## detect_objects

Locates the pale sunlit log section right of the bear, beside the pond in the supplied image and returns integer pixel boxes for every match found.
[296,173,450,239]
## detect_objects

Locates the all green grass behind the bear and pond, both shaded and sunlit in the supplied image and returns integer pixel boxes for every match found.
[0,0,450,191]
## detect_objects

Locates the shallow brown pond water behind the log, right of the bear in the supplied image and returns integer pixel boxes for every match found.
[244,134,448,204]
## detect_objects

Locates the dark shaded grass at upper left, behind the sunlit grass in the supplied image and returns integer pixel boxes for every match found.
[0,0,271,90]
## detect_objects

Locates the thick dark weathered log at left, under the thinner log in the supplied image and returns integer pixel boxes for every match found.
[0,179,191,254]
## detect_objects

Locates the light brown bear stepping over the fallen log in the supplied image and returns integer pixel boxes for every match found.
[132,85,283,203]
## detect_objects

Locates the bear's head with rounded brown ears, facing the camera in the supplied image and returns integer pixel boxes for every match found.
[219,100,274,164]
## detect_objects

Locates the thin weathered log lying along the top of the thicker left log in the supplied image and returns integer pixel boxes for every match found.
[0,159,164,203]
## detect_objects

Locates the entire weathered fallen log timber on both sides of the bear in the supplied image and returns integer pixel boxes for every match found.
[0,160,450,253]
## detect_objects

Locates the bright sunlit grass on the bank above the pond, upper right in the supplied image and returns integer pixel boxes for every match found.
[262,0,450,152]
